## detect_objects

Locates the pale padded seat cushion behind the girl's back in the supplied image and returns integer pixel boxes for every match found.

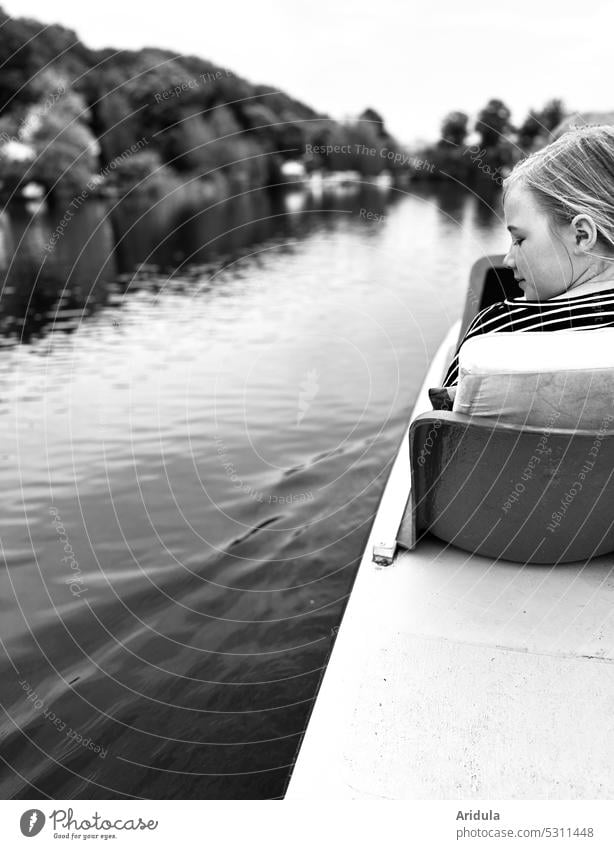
[453,328,614,429]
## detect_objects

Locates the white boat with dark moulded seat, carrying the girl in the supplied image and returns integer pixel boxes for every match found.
[285,256,614,800]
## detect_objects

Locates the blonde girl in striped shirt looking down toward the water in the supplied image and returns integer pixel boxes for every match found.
[430,126,614,409]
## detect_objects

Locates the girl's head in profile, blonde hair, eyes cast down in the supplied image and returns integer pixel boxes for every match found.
[503,126,614,301]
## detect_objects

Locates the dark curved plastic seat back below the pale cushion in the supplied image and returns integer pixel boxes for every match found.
[410,411,614,564]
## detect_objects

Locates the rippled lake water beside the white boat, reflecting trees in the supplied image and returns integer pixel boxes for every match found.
[0,177,507,799]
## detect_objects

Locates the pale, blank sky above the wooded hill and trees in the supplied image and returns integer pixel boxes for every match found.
[0,0,614,144]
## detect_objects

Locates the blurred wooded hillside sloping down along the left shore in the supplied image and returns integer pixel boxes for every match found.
[0,9,412,199]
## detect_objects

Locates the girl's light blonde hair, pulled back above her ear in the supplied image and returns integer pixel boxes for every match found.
[503,124,614,254]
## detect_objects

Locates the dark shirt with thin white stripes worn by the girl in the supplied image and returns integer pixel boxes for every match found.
[443,288,614,387]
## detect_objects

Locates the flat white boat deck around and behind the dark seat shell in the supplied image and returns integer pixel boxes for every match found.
[286,325,614,800]
